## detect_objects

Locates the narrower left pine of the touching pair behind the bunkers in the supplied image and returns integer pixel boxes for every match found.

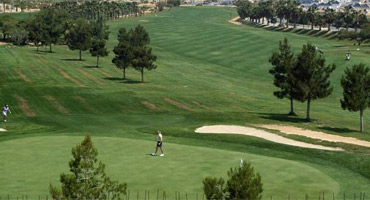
[269,38,295,115]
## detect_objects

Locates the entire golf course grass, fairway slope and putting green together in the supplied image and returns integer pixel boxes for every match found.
[0,7,370,199]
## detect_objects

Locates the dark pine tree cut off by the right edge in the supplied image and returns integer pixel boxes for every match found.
[340,64,370,132]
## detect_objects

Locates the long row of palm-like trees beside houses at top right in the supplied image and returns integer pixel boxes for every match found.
[237,0,369,32]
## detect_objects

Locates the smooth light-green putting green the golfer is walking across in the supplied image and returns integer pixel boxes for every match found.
[0,136,340,199]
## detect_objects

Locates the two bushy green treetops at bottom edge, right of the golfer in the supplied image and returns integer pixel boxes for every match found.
[203,162,263,200]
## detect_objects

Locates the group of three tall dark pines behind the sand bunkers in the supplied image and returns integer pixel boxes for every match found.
[269,38,370,132]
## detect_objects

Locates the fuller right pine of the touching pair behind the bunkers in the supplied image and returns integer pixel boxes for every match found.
[291,43,336,121]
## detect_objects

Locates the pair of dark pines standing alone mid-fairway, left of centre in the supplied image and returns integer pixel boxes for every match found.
[112,25,157,82]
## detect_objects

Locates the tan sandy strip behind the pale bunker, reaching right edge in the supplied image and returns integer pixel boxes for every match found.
[259,124,370,147]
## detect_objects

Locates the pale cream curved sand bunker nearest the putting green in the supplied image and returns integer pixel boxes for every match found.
[195,125,343,151]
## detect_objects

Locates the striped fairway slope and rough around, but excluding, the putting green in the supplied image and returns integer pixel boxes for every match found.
[0,8,370,198]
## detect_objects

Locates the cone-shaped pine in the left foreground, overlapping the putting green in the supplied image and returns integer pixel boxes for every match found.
[49,135,127,200]
